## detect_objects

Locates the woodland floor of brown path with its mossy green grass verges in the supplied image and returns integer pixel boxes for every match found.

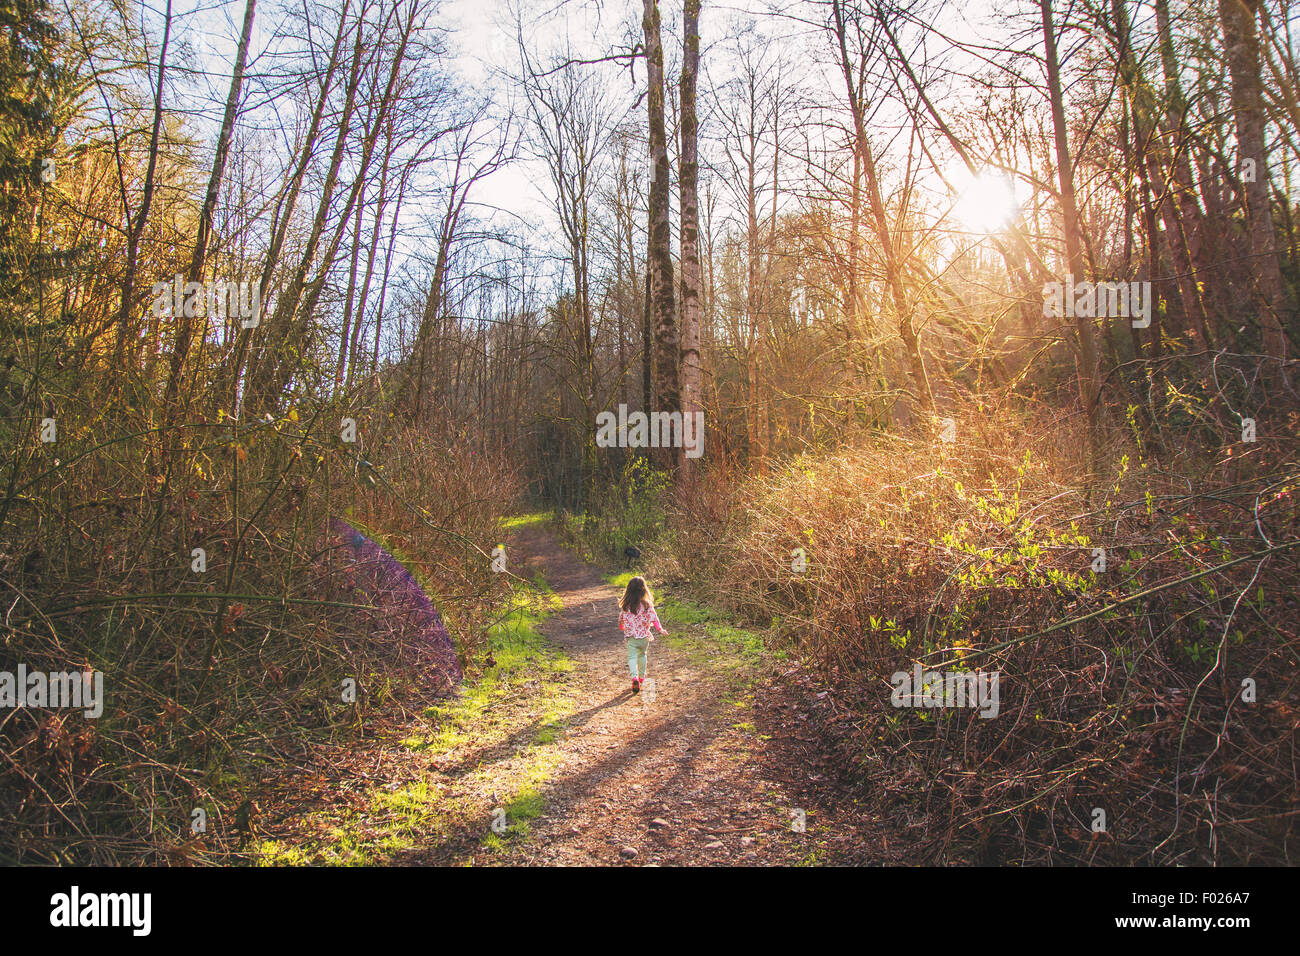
[252,525,883,866]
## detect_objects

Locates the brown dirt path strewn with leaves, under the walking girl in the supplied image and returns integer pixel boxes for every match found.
[426,528,883,865]
